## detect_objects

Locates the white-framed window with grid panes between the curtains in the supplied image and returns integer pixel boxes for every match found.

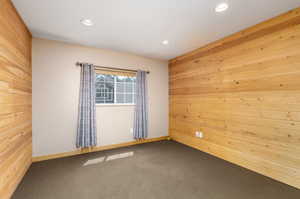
[96,72,136,104]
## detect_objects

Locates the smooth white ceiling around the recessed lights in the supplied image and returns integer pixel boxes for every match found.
[13,0,300,60]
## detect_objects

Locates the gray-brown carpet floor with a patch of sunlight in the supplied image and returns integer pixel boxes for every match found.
[12,141,300,199]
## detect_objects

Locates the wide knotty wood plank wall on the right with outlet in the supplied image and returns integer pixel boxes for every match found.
[169,8,300,188]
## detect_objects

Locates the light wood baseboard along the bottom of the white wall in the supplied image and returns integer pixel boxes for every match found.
[32,136,170,162]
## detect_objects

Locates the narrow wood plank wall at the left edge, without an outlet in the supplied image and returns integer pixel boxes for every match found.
[0,0,32,199]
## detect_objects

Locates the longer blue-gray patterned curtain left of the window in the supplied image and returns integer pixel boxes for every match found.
[76,63,97,148]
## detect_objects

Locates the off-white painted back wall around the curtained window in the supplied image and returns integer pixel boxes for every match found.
[32,38,168,157]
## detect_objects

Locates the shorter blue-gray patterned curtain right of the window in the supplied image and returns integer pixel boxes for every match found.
[133,70,148,139]
